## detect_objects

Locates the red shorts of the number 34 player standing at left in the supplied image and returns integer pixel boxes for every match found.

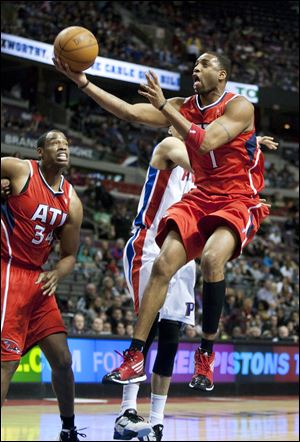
[1,260,66,361]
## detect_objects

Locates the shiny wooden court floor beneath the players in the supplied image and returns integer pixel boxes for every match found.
[1,397,299,441]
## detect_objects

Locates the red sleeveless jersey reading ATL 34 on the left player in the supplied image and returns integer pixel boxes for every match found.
[1,161,73,269]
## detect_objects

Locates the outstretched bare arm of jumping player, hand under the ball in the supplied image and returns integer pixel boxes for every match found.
[53,58,176,127]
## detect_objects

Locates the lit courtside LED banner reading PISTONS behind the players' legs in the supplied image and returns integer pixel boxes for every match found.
[13,338,299,384]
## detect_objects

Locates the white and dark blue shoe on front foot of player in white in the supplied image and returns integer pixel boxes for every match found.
[114,408,152,440]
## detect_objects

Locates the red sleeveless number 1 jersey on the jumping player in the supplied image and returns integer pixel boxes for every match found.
[180,91,264,196]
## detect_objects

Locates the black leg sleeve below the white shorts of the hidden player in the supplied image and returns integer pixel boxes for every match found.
[153,319,181,377]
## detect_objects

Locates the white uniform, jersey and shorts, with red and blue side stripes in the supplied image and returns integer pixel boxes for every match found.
[123,158,196,325]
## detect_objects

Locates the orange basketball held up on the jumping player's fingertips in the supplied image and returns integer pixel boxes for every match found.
[54,26,99,72]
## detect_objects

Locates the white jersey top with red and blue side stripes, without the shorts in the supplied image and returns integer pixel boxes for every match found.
[133,145,195,235]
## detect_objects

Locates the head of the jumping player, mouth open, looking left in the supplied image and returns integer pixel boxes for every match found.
[193,54,225,95]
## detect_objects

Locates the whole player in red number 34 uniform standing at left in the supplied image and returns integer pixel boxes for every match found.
[1,130,82,441]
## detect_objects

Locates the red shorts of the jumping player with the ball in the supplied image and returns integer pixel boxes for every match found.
[156,189,269,261]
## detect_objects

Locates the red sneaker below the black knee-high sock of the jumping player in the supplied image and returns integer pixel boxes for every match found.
[189,348,215,391]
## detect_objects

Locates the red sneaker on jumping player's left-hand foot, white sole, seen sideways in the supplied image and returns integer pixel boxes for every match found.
[102,349,147,384]
